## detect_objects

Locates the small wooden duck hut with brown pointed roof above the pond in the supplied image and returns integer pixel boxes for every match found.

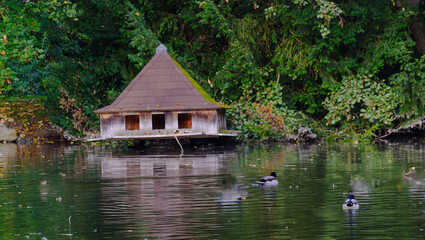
[95,44,232,140]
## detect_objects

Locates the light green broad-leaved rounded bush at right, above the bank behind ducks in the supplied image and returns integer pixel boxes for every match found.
[324,71,397,131]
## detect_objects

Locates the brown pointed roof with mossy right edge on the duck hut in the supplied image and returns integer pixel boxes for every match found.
[95,44,221,113]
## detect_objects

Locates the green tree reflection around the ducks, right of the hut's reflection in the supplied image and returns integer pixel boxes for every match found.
[234,144,425,238]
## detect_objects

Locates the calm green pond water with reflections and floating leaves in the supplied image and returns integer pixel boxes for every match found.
[0,143,425,240]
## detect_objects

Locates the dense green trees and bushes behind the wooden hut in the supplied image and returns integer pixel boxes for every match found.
[0,0,425,140]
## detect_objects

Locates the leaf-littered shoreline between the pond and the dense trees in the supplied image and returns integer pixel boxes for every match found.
[0,97,425,145]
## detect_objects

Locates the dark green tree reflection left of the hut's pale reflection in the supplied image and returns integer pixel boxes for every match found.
[0,144,103,239]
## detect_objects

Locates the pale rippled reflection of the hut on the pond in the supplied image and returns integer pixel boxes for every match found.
[89,154,237,239]
